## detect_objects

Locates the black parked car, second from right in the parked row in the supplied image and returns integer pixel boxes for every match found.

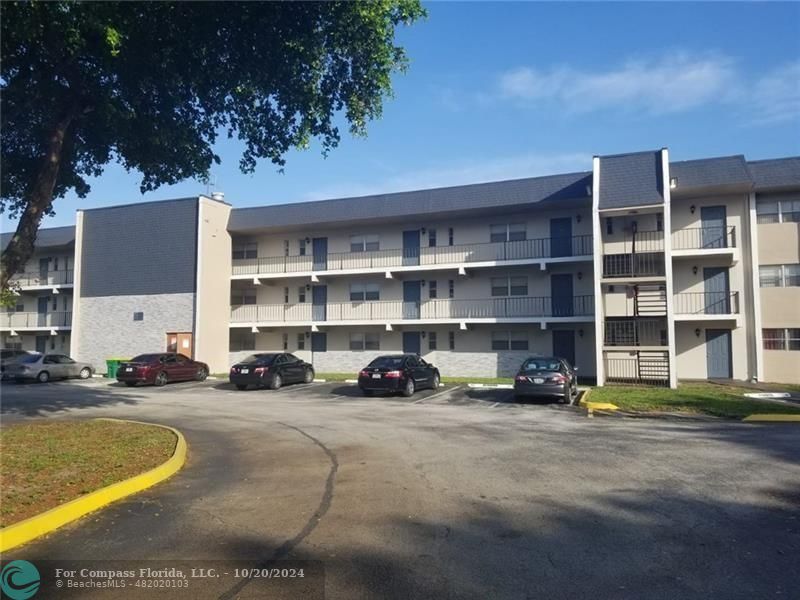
[358,354,441,397]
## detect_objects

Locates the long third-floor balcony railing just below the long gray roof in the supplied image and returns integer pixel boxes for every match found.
[233,235,592,275]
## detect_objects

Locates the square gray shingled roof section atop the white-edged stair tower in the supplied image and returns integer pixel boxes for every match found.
[598,150,664,209]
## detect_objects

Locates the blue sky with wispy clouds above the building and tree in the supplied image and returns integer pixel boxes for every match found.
[2,2,800,230]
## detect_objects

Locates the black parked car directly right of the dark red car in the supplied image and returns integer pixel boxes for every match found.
[228,352,314,390]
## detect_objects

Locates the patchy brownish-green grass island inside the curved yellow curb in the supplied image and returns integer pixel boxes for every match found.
[0,421,177,527]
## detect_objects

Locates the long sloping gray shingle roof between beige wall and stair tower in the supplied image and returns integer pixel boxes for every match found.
[228,172,592,232]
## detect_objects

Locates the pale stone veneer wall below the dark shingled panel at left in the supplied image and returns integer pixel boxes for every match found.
[74,294,194,373]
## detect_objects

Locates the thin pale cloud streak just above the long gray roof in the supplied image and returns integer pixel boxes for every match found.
[304,152,592,200]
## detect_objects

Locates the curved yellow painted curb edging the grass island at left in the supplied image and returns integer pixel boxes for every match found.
[0,419,186,552]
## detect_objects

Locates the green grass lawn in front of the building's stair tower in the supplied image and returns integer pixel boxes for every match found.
[590,383,800,419]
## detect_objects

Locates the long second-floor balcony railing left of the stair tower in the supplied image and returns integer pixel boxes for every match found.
[231,296,594,323]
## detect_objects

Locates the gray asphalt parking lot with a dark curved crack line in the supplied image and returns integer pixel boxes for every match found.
[0,379,800,600]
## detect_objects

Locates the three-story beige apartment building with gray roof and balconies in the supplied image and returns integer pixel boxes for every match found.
[2,149,800,386]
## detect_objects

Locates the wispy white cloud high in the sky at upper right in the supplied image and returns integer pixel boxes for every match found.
[498,52,737,114]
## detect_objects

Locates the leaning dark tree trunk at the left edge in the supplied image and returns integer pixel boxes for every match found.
[0,109,75,290]
